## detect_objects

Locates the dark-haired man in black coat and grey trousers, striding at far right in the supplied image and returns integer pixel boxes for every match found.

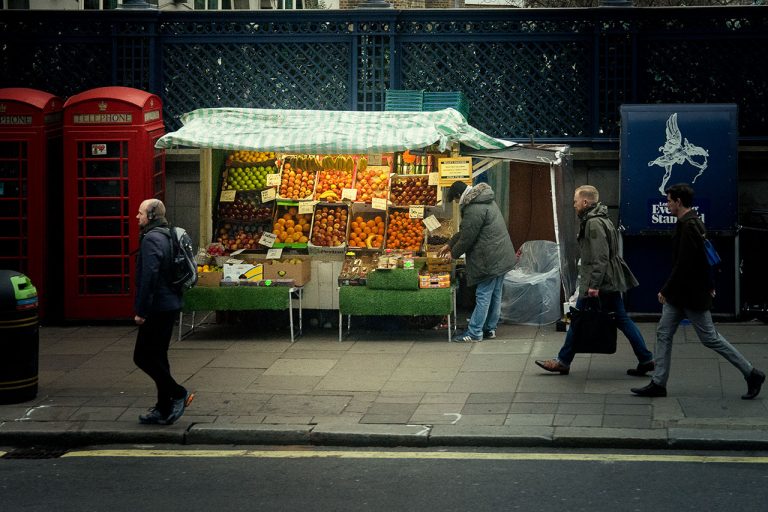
[631,183,765,400]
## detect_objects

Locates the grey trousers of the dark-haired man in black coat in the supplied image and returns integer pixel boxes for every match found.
[652,303,752,387]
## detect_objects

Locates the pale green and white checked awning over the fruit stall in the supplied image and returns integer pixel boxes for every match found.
[155,108,513,154]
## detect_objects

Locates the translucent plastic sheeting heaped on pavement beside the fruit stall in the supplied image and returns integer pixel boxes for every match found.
[501,240,562,325]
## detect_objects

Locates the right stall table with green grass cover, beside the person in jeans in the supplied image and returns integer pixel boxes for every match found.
[339,285,456,341]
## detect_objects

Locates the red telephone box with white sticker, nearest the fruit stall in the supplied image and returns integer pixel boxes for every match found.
[64,87,165,319]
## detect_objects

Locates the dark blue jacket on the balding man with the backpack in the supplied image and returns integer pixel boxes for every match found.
[134,224,183,318]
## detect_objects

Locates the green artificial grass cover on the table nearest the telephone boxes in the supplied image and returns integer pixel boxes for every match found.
[183,286,290,312]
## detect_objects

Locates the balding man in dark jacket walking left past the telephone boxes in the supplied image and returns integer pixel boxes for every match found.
[133,199,195,425]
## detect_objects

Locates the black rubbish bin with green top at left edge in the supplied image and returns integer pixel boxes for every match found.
[0,270,40,404]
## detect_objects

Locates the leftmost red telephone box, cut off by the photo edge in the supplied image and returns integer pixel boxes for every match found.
[0,87,64,317]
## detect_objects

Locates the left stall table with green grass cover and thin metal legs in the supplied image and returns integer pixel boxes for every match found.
[179,286,304,343]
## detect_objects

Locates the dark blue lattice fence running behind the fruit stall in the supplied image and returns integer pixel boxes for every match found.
[0,6,768,145]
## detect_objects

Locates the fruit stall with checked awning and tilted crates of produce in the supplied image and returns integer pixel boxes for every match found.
[157,109,512,336]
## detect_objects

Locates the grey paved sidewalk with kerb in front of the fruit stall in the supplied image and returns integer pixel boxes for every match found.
[0,316,768,449]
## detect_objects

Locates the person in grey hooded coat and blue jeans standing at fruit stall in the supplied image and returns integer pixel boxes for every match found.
[438,181,516,343]
